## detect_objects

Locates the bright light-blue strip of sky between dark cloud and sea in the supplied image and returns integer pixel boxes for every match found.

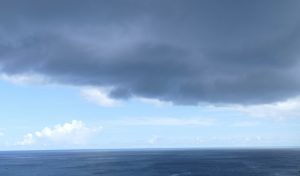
[0,80,300,150]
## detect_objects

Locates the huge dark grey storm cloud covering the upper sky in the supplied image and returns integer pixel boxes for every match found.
[0,0,300,104]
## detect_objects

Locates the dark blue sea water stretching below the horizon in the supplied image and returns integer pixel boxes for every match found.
[0,149,300,176]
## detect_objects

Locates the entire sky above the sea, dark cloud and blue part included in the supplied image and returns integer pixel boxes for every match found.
[0,0,300,150]
